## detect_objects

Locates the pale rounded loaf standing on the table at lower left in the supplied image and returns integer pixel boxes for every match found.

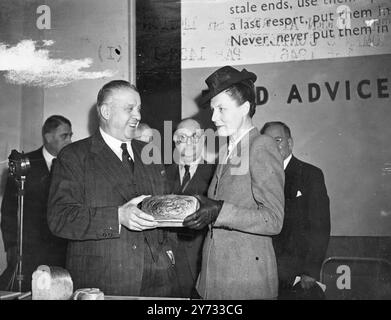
[31,265,73,300]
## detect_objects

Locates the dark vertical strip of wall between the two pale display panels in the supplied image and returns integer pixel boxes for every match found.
[136,0,181,140]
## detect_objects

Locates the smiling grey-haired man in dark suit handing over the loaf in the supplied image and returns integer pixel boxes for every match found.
[48,80,181,296]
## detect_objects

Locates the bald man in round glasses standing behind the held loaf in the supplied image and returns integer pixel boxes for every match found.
[167,119,216,298]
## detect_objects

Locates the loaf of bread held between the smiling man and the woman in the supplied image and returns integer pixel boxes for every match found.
[141,194,199,220]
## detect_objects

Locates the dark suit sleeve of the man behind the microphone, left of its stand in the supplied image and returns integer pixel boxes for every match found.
[1,177,18,252]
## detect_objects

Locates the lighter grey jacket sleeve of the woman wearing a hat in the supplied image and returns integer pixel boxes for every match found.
[215,139,285,235]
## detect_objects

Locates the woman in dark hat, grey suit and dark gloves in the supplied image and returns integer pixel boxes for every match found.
[183,66,284,299]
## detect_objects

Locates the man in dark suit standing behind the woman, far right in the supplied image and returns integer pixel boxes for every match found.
[261,122,330,299]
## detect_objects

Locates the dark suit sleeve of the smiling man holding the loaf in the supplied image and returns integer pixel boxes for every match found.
[47,149,119,240]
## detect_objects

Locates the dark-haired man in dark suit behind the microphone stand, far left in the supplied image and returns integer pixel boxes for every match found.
[0,115,72,291]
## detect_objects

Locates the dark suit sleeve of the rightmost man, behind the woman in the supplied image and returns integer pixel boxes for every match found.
[303,170,330,279]
